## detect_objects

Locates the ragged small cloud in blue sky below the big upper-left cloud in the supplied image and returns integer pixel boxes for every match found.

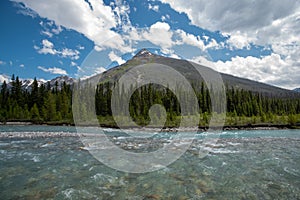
[34,39,80,60]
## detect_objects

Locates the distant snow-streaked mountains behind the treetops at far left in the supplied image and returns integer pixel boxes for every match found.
[7,76,75,91]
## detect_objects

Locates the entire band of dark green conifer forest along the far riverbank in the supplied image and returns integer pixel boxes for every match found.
[0,76,300,126]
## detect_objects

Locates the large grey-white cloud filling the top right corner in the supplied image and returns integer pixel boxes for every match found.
[161,0,300,53]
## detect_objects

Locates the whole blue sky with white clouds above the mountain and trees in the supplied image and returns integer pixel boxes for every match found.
[0,0,300,89]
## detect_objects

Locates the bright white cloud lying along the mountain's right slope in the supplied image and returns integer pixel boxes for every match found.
[191,53,300,89]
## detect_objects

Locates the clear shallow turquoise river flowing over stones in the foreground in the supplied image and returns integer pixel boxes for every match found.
[0,126,300,199]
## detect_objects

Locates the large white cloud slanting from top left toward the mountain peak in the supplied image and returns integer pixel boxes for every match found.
[15,0,130,52]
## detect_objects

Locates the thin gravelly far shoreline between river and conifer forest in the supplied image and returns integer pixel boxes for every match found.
[0,122,300,140]
